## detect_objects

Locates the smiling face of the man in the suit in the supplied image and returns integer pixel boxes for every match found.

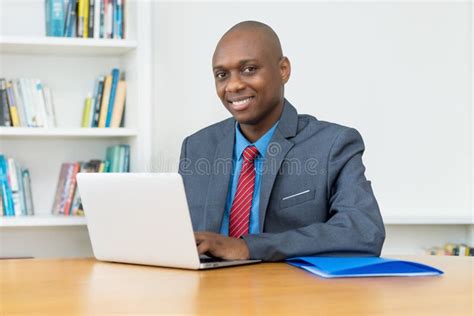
[212,24,290,131]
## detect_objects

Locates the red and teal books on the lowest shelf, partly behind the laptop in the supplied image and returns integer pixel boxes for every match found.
[51,145,130,215]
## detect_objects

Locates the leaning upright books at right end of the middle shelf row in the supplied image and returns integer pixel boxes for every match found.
[81,68,126,128]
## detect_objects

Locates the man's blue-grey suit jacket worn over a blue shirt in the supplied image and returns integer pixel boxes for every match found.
[179,100,385,261]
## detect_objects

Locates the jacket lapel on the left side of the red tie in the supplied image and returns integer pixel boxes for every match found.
[203,120,235,233]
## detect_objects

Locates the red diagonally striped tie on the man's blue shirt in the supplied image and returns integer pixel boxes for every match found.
[229,146,258,238]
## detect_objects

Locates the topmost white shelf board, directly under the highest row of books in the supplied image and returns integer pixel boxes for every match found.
[0,36,137,56]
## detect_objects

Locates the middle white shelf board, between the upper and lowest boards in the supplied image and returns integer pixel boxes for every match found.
[0,127,138,138]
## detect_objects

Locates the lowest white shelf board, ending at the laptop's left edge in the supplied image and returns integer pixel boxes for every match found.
[0,215,87,227]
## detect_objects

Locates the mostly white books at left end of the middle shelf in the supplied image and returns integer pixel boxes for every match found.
[0,78,56,127]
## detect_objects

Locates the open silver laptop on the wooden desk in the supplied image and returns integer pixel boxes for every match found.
[77,173,259,269]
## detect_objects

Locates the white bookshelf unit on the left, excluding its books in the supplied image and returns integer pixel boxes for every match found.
[0,0,152,257]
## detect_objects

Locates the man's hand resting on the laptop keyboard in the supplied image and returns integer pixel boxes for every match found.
[194,232,250,260]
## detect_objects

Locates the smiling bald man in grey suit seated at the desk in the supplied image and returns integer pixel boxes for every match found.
[179,21,385,261]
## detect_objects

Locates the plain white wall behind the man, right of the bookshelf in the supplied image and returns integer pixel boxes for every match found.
[151,2,473,225]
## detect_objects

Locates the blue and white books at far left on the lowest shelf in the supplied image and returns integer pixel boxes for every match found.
[0,155,34,216]
